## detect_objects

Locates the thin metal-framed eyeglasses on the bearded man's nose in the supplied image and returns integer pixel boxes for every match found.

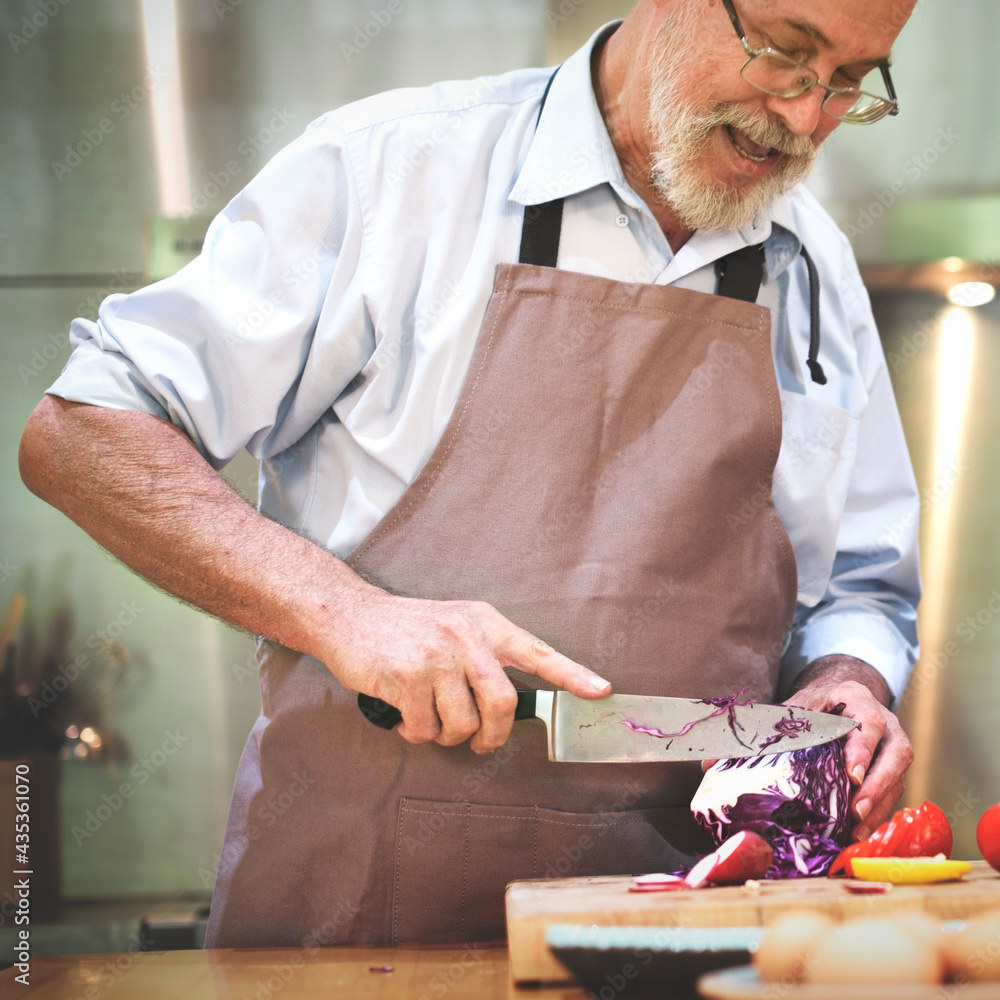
[722,0,899,125]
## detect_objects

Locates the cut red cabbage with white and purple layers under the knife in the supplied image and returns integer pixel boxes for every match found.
[691,740,850,879]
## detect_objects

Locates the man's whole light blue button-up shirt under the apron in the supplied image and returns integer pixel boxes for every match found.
[49,26,920,697]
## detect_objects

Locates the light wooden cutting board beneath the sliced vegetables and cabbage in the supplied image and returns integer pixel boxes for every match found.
[507,861,1000,982]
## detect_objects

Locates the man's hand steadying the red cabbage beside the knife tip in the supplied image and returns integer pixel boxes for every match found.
[785,656,913,840]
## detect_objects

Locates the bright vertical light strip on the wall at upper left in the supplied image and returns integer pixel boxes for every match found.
[140,0,191,216]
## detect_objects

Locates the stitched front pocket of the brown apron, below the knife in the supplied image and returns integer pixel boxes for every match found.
[392,798,711,944]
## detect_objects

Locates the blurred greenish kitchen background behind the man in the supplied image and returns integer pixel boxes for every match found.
[0,0,1000,952]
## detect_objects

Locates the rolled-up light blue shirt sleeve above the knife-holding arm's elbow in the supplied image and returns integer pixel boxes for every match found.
[48,111,374,468]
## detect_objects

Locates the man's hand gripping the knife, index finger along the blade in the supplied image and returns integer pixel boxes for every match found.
[324,587,611,753]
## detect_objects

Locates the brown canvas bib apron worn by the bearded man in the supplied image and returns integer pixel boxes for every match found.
[206,193,796,947]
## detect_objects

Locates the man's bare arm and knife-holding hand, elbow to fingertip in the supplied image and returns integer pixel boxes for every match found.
[21,397,610,751]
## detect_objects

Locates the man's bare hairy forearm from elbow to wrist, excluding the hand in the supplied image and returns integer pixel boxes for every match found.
[20,396,368,654]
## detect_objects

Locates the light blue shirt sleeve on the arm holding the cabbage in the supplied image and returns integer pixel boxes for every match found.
[781,265,921,704]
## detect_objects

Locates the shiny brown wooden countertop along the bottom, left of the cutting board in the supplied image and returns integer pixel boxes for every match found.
[0,945,588,1000]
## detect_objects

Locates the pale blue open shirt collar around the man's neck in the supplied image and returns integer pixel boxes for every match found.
[510,21,802,281]
